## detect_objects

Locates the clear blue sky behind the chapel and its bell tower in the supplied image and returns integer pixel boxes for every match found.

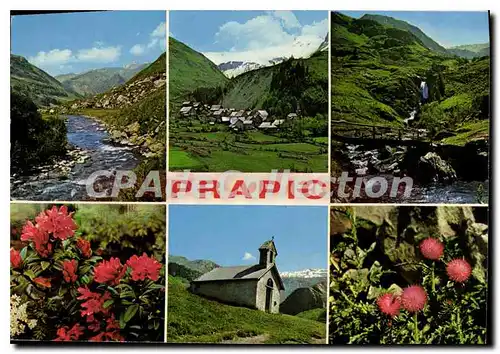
[168,205,328,272]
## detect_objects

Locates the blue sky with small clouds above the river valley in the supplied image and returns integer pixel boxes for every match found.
[11,11,166,75]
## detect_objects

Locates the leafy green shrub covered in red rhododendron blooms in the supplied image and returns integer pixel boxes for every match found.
[10,206,165,341]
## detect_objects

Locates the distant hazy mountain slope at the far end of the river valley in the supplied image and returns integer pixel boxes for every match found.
[56,64,147,96]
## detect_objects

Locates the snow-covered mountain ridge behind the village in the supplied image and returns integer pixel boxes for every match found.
[203,35,328,77]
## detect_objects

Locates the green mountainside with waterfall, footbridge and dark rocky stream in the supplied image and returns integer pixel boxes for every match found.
[331,12,491,202]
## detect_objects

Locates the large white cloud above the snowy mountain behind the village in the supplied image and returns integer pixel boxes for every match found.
[203,11,328,65]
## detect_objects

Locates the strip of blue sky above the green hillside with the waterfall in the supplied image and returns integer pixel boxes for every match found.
[341,11,489,47]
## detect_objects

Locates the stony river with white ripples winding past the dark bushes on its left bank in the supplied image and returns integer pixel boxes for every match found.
[11,115,141,201]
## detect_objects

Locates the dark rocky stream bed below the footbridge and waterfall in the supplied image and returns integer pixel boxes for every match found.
[334,141,489,203]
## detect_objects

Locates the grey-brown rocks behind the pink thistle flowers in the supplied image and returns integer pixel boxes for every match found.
[331,205,488,282]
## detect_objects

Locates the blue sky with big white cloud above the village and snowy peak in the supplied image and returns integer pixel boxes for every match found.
[169,11,328,64]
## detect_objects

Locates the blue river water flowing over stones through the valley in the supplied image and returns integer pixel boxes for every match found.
[11,116,140,201]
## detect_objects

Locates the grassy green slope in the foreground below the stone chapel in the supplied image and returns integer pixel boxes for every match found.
[167,276,326,344]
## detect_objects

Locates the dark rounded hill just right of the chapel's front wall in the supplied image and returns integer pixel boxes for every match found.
[280,281,326,315]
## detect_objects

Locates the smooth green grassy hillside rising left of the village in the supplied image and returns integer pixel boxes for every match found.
[168,37,228,103]
